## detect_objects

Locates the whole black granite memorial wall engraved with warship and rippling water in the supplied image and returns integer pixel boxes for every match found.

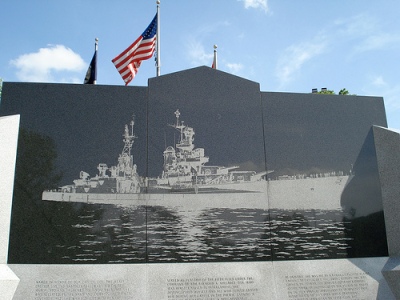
[0,67,386,263]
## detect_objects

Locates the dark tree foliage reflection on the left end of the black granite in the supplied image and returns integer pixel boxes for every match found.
[8,128,62,263]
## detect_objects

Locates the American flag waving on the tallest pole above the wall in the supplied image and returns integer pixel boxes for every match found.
[112,14,157,85]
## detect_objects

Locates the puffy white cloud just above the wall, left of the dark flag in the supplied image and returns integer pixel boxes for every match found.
[10,45,88,82]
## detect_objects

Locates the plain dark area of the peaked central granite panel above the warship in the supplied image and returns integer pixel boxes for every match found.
[149,67,265,176]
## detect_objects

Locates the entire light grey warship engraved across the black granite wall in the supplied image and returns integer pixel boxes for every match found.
[42,110,349,208]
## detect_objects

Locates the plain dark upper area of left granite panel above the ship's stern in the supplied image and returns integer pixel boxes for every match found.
[0,82,147,185]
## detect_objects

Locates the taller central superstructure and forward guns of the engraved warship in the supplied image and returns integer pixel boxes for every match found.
[148,110,267,192]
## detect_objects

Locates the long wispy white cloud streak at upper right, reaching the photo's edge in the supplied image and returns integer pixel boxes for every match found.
[276,14,400,88]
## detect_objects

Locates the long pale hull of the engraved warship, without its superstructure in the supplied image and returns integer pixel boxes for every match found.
[42,176,349,210]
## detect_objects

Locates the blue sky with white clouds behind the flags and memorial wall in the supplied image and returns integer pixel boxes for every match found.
[0,0,400,130]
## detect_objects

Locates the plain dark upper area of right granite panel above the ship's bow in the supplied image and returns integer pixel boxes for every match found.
[261,92,387,178]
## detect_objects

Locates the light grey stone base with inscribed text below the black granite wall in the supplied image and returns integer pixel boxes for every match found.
[9,257,399,300]
